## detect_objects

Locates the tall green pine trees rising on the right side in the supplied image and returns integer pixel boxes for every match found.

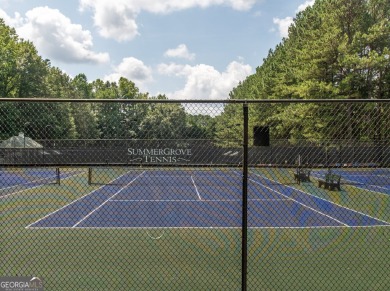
[222,0,390,140]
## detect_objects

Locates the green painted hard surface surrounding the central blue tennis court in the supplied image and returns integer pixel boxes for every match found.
[0,170,390,290]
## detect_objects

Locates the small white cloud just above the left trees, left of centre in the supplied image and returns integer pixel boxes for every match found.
[104,57,153,89]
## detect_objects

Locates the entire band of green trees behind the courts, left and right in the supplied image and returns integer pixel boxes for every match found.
[0,0,390,144]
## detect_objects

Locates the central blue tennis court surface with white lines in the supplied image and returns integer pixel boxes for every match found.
[22,170,390,228]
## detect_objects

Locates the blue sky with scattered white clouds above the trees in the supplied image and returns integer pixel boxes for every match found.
[0,0,314,100]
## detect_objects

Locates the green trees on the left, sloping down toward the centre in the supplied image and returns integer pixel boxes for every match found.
[0,19,214,140]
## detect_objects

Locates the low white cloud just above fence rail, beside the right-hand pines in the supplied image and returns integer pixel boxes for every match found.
[158,61,252,100]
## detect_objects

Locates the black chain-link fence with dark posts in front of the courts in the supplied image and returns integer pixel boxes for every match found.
[0,99,390,290]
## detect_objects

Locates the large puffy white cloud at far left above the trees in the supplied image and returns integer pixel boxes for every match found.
[0,7,110,64]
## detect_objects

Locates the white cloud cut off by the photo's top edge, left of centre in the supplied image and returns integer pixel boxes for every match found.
[79,0,256,41]
